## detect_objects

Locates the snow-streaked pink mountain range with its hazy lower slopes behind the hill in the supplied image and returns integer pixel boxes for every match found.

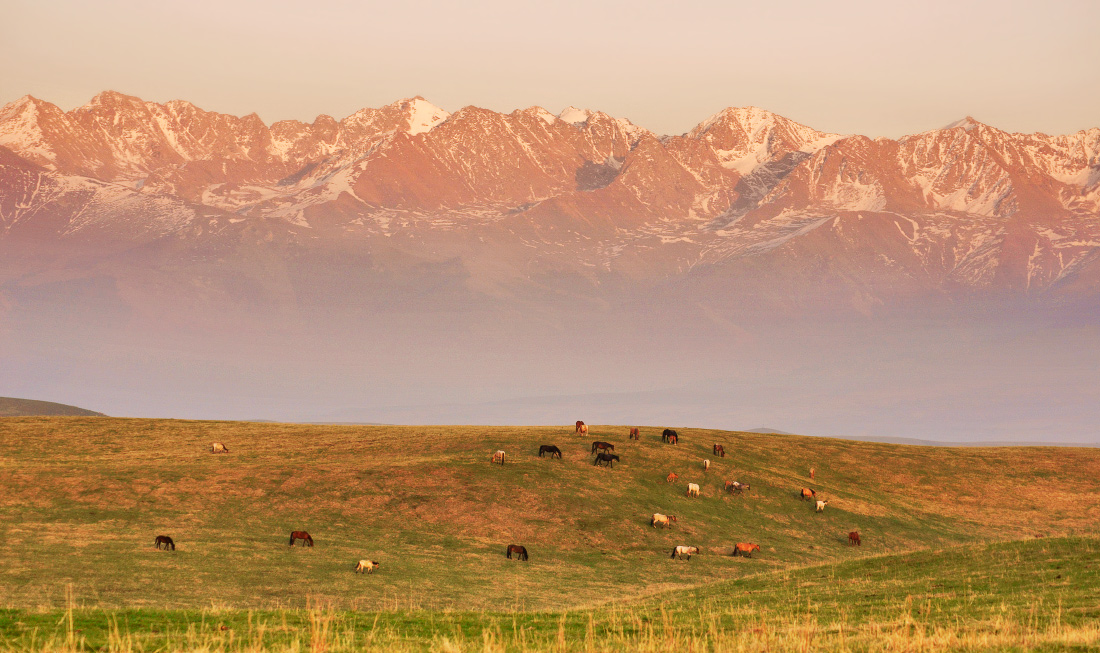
[0,91,1100,433]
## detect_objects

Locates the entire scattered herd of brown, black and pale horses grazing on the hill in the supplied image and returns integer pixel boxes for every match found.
[154,420,862,574]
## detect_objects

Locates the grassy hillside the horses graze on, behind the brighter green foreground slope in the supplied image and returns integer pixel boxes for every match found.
[0,418,1100,610]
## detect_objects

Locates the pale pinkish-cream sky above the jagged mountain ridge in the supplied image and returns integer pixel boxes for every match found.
[0,0,1100,136]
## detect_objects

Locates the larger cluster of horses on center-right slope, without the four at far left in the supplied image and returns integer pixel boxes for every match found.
[492,420,861,560]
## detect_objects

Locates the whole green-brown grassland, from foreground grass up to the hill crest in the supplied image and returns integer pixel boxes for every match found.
[0,418,1100,650]
